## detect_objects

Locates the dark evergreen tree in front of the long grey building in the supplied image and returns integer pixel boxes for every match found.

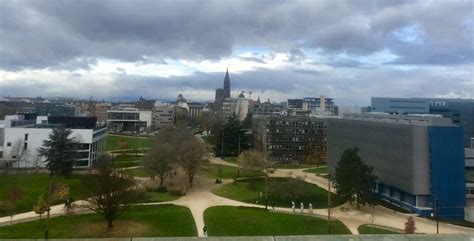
[335,147,377,208]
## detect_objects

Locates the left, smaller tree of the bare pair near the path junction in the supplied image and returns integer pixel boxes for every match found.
[142,142,178,187]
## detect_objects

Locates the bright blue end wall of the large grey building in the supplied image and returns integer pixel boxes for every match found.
[429,126,466,219]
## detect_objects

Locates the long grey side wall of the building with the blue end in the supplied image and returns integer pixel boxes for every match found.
[327,119,430,195]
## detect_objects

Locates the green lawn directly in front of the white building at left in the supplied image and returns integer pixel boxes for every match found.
[0,174,87,216]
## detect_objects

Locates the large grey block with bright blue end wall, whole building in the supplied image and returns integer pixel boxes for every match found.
[327,114,466,219]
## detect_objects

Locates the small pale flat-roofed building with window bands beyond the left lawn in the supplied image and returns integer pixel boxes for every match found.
[107,107,152,133]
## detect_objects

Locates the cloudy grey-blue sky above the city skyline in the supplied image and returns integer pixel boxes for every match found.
[0,0,474,106]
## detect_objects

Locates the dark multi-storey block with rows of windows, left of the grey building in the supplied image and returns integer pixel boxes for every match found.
[252,115,326,164]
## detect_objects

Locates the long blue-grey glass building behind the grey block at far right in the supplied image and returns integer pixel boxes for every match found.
[371,97,474,147]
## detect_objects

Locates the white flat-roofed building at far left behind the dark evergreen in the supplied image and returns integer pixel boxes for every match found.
[0,116,107,168]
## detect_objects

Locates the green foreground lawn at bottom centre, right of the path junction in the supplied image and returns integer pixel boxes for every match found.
[204,206,350,236]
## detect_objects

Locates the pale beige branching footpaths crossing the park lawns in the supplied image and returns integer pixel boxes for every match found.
[0,158,474,237]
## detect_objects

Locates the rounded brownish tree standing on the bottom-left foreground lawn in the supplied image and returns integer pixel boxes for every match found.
[83,154,140,228]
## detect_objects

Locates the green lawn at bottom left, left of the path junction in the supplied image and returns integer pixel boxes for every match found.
[0,205,197,239]
